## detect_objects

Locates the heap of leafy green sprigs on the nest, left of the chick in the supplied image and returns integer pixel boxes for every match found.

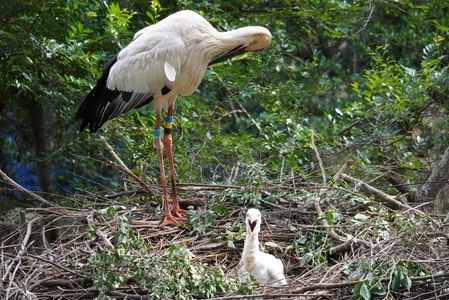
[84,207,247,299]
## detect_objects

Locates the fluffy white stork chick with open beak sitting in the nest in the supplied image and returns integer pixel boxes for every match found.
[238,208,287,286]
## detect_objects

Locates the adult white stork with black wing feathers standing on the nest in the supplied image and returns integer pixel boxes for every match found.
[76,10,271,226]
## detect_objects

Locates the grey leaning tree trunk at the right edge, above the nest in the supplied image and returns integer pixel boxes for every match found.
[415,147,449,202]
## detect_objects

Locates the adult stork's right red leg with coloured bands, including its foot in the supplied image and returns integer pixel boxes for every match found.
[164,105,187,218]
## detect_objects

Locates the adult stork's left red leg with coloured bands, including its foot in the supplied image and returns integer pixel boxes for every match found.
[154,112,178,226]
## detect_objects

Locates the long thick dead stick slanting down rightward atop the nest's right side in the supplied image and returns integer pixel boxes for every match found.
[341,173,439,227]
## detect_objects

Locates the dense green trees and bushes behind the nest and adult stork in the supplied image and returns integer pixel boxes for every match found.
[0,0,449,203]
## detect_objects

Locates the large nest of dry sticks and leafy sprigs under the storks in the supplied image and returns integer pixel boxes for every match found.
[0,174,449,299]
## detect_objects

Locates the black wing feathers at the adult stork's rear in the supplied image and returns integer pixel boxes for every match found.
[75,55,153,132]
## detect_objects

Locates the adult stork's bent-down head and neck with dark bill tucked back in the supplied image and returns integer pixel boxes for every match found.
[209,26,271,65]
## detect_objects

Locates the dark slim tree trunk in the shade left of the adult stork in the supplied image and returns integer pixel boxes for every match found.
[28,99,51,193]
